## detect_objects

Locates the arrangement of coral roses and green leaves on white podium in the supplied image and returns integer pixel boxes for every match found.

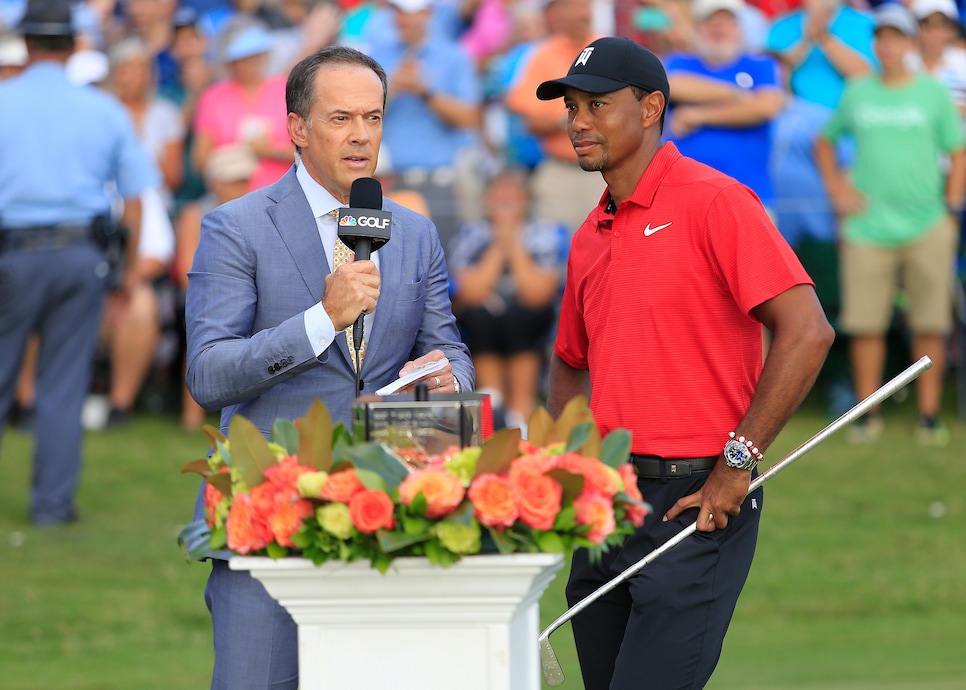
[179,397,649,572]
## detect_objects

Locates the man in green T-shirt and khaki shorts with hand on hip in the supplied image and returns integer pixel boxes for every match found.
[815,4,966,445]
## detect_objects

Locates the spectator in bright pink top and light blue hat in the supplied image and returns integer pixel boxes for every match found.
[193,26,294,189]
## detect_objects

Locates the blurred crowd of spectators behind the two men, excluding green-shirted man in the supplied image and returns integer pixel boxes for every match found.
[0,0,966,442]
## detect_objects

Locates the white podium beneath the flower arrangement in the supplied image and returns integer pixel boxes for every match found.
[229,553,563,690]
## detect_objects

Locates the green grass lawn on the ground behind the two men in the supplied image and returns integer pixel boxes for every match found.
[0,390,966,690]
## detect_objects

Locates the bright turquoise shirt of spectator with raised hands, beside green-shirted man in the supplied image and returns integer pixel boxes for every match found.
[765,6,878,108]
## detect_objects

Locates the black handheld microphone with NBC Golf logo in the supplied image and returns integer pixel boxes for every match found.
[339,177,392,366]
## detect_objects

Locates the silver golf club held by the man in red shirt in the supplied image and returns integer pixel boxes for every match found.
[538,357,932,686]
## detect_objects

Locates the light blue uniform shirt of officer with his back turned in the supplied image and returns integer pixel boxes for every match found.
[0,62,159,228]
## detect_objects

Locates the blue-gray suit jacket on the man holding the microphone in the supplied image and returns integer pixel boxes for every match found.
[185,166,474,436]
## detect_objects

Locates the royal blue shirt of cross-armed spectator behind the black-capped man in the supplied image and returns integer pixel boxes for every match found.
[665,53,781,207]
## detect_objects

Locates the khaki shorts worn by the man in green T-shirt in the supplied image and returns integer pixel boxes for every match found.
[839,218,957,335]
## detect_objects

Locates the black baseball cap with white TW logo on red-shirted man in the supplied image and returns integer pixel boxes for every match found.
[537,36,671,102]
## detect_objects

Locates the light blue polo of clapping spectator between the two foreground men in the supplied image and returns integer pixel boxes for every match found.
[369,38,481,171]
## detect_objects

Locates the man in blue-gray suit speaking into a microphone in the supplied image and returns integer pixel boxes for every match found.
[186,47,474,690]
